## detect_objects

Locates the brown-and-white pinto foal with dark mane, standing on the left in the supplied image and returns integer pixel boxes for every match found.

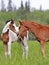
[1,20,28,58]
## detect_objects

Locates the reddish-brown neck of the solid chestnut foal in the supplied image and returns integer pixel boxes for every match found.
[24,22,41,34]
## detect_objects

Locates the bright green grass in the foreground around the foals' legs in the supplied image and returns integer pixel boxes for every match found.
[0,41,49,65]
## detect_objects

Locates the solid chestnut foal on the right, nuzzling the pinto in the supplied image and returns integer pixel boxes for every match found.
[19,20,49,57]
